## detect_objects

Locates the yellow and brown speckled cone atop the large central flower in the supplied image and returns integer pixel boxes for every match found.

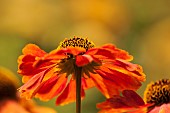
[58,37,95,51]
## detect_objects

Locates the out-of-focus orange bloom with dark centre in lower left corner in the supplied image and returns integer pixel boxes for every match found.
[0,67,56,113]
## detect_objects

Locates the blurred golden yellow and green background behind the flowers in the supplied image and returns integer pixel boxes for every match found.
[0,0,170,113]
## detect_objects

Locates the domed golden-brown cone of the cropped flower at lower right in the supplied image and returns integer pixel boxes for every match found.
[144,79,170,106]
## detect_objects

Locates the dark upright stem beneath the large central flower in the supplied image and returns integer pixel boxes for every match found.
[75,65,82,113]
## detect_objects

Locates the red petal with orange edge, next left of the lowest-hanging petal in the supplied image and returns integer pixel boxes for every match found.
[36,75,67,100]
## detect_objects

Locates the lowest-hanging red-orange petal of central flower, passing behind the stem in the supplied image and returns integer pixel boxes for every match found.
[56,80,85,105]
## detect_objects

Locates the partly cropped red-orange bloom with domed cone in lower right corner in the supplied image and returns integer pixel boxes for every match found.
[97,79,170,113]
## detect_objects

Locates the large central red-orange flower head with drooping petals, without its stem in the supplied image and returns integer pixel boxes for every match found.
[18,37,145,105]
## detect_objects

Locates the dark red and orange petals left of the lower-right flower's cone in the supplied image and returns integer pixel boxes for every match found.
[96,90,150,113]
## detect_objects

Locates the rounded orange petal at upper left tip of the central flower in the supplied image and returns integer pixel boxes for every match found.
[22,44,46,57]
